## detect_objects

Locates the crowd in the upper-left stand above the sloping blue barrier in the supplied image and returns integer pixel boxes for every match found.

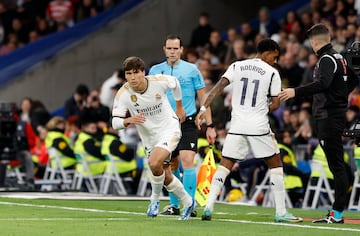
[0,0,123,56]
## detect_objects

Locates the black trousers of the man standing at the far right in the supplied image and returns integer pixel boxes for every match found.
[316,116,349,212]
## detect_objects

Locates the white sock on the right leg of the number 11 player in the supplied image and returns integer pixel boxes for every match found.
[270,167,286,215]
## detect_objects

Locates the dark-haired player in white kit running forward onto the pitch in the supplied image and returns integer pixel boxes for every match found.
[112,57,195,220]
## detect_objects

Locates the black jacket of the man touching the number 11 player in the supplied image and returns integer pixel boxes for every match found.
[295,44,356,120]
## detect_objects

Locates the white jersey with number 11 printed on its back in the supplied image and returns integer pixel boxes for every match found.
[223,58,281,135]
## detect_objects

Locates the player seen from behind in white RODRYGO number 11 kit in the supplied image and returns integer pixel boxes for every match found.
[196,39,302,222]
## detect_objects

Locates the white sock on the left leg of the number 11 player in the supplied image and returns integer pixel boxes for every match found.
[205,165,230,211]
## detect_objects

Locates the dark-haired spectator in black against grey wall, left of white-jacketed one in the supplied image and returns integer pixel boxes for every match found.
[64,84,89,119]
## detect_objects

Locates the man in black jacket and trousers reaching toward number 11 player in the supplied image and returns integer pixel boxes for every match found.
[279,24,357,224]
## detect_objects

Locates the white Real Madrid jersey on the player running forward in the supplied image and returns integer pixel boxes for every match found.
[112,75,181,149]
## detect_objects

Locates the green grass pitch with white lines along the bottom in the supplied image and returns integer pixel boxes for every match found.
[0,198,360,236]
